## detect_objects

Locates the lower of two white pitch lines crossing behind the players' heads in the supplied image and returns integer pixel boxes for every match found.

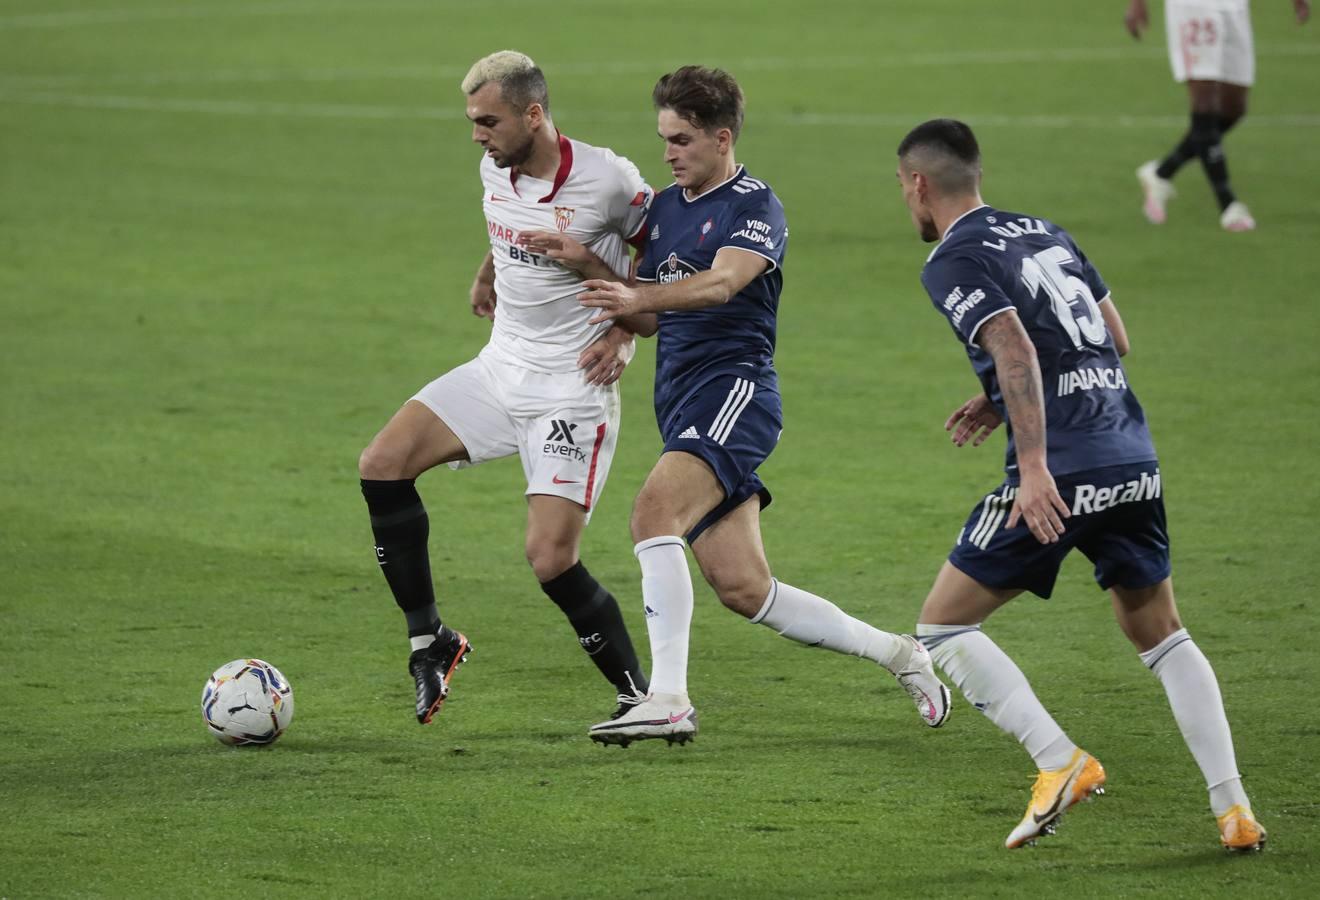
[10,91,1320,129]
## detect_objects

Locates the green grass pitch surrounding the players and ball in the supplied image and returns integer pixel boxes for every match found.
[0,0,1320,897]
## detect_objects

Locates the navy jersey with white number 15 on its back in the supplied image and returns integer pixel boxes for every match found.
[921,206,1155,484]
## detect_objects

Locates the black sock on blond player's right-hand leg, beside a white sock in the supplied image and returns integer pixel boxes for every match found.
[541,562,648,694]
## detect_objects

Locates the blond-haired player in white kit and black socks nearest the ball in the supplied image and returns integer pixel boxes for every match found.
[359,50,652,724]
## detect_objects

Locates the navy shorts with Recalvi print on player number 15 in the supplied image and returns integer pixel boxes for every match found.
[949,461,1172,599]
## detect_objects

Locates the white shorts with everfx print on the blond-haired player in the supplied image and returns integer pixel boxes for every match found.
[412,350,619,517]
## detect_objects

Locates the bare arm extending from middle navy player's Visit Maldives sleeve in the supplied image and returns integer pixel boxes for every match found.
[578,247,770,323]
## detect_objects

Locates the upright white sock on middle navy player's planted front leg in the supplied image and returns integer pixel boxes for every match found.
[632,534,692,697]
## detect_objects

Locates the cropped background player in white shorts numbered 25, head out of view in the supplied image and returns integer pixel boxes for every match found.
[1123,0,1311,231]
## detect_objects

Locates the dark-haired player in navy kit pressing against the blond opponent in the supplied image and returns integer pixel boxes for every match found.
[579,66,949,746]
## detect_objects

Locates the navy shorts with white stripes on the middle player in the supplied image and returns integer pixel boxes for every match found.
[663,375,784,544]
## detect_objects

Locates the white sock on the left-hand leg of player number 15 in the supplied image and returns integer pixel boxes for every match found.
[916,624,1077,772]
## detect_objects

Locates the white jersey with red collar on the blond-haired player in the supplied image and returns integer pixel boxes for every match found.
[480,136,653,372]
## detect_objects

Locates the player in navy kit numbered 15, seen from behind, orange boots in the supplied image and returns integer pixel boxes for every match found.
[898,119,1265,850]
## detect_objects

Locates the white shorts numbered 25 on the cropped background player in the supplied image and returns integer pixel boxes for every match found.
[1164,0,1255,87]
